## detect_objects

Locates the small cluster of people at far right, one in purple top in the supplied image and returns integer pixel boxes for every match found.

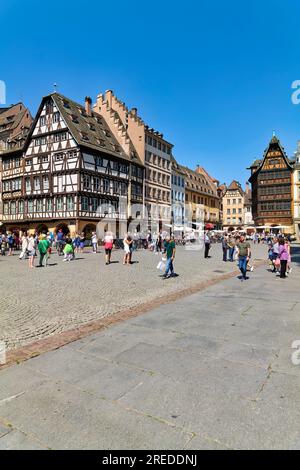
[268,235,292,279]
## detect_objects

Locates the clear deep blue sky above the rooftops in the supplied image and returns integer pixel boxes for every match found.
[0,0,300,184]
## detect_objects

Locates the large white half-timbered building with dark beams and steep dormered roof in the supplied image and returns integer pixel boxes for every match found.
[2,93,144,236]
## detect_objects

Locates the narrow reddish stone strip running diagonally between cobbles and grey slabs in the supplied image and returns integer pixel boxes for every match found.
[0,260,266,370]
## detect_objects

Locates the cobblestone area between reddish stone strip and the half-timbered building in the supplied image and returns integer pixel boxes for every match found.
[0,244,267,349]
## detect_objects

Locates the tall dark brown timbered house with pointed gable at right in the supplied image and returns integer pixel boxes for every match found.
[249,135,294,233]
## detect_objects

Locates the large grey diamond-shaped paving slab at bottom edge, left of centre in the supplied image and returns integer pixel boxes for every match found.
[0,382,192,449]
